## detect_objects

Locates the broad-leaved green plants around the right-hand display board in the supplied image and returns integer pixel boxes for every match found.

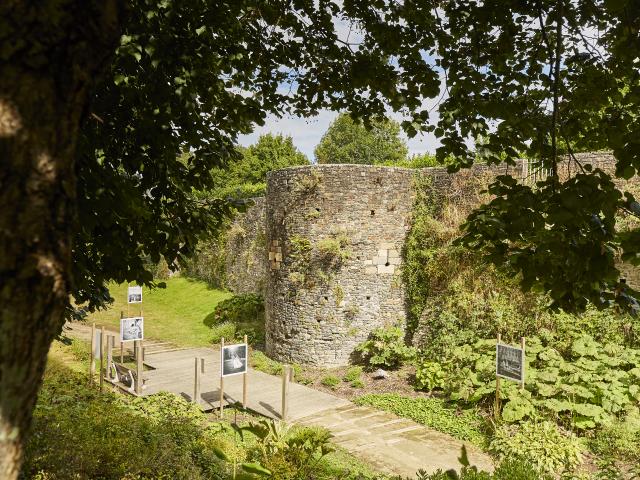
[416,335,640,430]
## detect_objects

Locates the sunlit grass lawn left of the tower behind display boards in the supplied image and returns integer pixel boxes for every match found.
[87,277,232,346]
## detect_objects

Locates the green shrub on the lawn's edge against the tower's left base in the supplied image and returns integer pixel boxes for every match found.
[205,293,264,344]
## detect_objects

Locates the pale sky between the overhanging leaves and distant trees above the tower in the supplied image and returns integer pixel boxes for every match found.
[238,110,439,161]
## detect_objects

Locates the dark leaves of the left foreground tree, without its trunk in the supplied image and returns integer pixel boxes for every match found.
[70,0,438,314]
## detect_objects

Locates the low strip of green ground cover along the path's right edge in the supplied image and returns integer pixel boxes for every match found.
[354,393,487,446]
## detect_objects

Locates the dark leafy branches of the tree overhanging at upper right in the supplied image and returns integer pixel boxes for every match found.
[435,0,640,310]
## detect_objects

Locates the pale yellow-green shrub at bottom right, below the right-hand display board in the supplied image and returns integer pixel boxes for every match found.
[489,421,582,475]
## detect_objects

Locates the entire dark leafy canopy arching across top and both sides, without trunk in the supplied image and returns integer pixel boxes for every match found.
[73,0,640,316]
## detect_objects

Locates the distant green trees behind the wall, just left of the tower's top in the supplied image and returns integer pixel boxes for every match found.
[211,133,310,198]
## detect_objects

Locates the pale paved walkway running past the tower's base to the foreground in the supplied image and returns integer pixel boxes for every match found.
[65,324,492,477]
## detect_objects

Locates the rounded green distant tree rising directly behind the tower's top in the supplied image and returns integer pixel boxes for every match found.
[315,113,407,165]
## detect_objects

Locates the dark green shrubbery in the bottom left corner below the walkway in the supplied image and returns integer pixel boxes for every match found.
[21,362,226,480]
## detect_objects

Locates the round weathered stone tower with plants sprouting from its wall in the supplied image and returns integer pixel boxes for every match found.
[265,165,415,366]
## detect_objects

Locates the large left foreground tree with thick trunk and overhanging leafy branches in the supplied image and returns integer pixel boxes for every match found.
[0,0,438,480]
